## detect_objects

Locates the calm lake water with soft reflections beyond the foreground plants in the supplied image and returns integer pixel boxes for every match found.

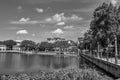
[0,53,79,74]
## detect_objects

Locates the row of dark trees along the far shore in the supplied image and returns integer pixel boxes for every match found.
[0,40,76,51]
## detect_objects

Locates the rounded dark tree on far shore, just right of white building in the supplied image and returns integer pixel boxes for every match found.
[20,40,36,51]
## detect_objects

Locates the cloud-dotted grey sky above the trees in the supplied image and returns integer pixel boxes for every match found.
[0,0,119,42]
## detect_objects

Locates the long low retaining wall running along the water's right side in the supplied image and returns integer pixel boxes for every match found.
[80,54,120,78]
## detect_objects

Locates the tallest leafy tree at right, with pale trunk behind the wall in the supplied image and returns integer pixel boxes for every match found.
[87,3,120,63]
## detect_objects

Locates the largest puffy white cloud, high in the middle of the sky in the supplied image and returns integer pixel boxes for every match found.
[46,13,83,23]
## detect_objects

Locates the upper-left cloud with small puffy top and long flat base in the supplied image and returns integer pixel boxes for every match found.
[10,18,40,24]
